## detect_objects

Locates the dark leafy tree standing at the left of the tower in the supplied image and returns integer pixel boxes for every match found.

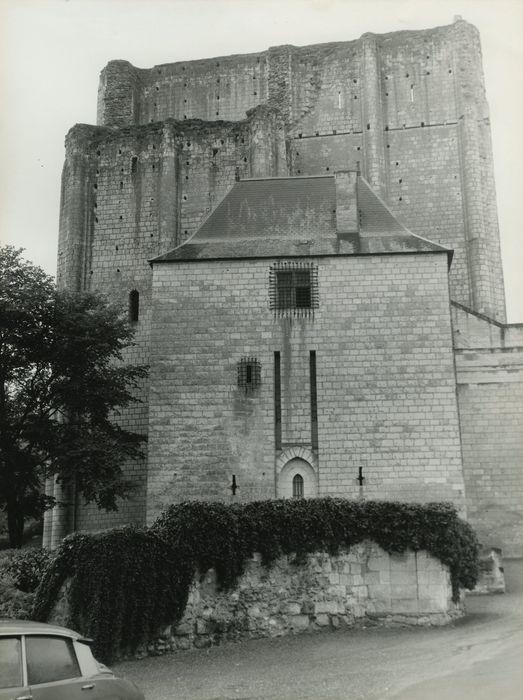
[0,246,146,547]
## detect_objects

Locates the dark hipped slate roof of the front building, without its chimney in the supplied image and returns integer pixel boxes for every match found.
[151,175,451,263]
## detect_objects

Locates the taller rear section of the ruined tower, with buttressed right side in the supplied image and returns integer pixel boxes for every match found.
[98,20,505,321]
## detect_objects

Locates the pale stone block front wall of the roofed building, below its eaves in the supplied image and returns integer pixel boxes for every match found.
[147,253,464,522]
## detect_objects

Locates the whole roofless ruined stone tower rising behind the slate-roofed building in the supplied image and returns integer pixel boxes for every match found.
[48,20,520,556]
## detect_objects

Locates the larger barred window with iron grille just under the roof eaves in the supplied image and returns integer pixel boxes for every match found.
[269,262,319,317]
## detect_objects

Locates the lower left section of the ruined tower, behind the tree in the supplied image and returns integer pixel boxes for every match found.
[57,108,285,529]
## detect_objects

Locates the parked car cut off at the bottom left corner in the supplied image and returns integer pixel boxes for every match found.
[0,620,145,700]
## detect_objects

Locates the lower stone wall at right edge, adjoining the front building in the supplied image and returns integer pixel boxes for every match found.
[452,305,523,557]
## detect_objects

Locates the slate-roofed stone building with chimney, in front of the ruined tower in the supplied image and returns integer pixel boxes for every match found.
[147,172,464,519]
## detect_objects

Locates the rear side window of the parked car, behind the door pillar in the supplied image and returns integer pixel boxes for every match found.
[25,636,81,685]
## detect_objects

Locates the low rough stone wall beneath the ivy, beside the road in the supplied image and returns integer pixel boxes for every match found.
[148,542,463,654]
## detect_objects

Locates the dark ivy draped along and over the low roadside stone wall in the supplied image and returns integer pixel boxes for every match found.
[33,498,478,661]
